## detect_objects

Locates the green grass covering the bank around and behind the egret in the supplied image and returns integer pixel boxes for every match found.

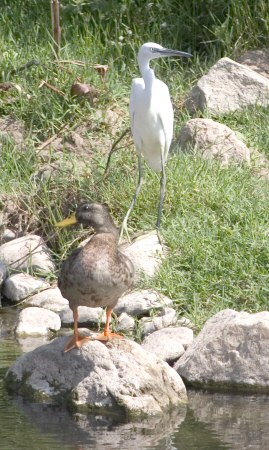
[0,0,269,328]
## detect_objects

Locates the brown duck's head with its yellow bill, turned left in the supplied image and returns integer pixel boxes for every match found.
[56,202,116,233]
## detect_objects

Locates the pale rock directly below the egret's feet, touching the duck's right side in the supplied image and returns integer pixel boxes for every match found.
[120,231,164,283]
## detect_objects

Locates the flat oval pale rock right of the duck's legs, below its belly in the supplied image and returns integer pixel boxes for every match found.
[114,289,173,317]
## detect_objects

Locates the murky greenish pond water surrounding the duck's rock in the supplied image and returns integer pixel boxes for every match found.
[0,309,269,450]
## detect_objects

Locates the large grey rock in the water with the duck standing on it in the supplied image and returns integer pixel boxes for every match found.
[6,338,187,415]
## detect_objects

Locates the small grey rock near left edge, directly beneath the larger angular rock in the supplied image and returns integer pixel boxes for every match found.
[2,273,49,302]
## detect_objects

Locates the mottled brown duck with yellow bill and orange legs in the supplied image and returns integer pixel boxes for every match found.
[56,203,134,352]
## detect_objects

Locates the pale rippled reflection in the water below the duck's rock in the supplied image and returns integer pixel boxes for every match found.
[11,398,186,450]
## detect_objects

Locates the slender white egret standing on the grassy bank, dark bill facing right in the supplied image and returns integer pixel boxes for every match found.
[121,42,192,236]
